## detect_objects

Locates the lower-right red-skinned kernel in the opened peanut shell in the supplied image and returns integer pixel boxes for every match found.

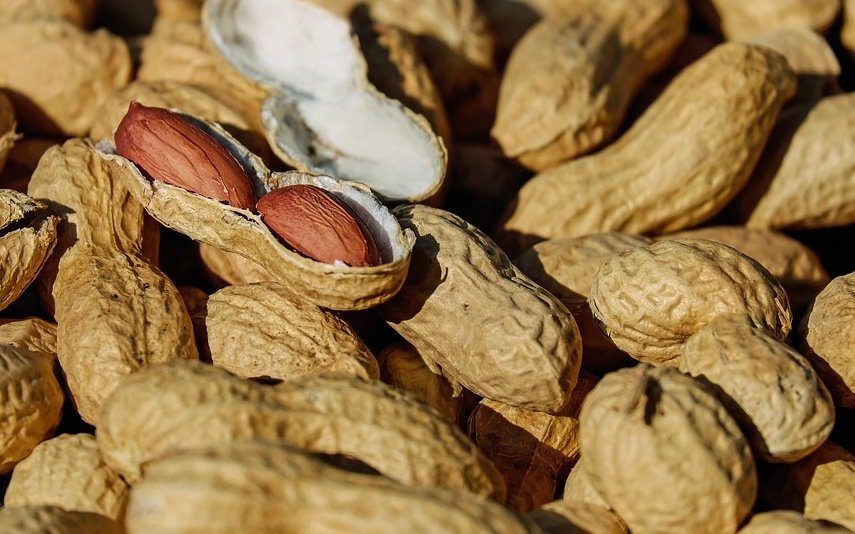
[257,185,380,267]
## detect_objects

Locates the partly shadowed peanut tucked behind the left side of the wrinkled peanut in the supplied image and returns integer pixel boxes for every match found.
[514,232,650,374]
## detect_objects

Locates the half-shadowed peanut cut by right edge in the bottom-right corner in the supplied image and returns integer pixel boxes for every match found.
[760,441,855,530]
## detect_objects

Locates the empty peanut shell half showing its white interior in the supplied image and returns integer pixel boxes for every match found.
[205,0,446,200]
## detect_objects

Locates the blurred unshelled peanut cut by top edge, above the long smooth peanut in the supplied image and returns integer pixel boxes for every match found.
[491,0,689,171]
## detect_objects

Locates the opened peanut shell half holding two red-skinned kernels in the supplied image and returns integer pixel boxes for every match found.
[100,105,413,310]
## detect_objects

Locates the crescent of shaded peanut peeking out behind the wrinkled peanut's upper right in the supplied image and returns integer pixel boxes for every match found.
[665,226,830,309]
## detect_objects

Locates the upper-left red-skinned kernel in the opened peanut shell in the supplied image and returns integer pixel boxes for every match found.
[114,101,255,210]
